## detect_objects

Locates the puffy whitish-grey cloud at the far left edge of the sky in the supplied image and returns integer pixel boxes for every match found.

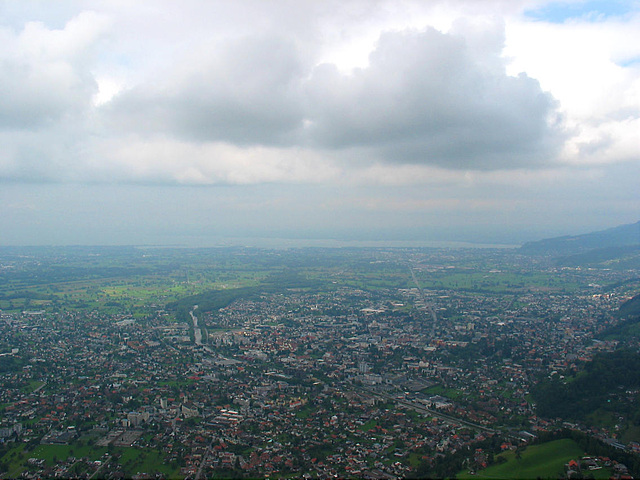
[0,12,109,129]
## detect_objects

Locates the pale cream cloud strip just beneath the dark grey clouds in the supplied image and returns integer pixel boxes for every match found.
[83,136,340,185]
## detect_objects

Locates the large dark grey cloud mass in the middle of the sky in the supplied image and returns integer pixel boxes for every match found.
[108,25,562,169]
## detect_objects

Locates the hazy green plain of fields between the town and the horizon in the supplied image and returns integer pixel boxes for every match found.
[0,247,608,318]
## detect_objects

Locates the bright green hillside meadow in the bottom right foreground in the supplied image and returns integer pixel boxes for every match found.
[457,439,611,479]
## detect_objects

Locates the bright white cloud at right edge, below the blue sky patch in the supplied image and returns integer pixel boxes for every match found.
[505,10,640,165]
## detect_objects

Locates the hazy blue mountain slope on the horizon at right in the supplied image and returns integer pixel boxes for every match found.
[520,222,640,256]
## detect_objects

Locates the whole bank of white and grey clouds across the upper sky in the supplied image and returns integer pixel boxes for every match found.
[0,1,640,183]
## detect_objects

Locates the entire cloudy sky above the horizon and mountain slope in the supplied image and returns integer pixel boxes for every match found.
[0,0,640,246]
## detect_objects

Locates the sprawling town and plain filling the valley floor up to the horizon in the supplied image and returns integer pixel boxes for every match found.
[0,248,640,479]
